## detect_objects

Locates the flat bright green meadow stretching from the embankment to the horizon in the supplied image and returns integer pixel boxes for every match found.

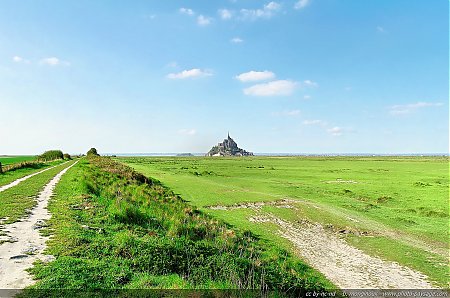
[119,157,449,287]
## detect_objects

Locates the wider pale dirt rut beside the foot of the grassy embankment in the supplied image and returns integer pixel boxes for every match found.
[0,161,78,289]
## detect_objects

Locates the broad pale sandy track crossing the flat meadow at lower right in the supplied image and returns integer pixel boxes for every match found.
[256,214,433,289]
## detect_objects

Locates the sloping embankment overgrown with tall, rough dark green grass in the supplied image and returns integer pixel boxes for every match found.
[31,157,333,296]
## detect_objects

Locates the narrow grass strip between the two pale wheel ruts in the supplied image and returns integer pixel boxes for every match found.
[0,163,74,224]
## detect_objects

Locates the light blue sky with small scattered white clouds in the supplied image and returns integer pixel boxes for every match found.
[0,0,449,155]
